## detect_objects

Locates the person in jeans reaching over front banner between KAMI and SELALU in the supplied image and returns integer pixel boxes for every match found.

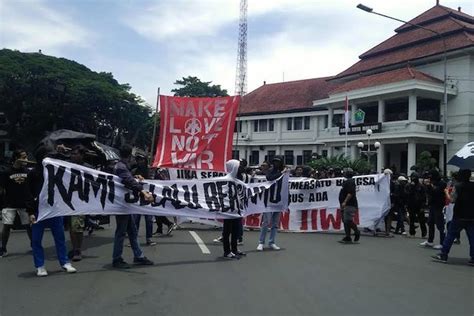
[112,145,153,269]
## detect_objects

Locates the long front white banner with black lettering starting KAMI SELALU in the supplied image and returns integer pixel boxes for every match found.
[38,158,288,220]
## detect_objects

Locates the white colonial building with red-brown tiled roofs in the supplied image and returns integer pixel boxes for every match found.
[234,5,474,173]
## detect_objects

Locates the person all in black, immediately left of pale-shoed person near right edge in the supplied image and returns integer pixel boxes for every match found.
[405,172,426,238]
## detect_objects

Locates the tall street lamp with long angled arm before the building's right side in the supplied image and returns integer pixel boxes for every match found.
[357,3,448,177]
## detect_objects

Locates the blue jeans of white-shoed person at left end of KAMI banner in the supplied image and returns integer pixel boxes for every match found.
[31,217,69,268]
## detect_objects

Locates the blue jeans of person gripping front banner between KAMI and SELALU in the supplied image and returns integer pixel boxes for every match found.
[112,215,143,262]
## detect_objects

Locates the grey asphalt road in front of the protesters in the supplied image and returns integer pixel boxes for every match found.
[0,225,474,316]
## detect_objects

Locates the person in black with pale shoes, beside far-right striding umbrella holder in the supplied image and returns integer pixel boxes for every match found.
[420,170,446,249]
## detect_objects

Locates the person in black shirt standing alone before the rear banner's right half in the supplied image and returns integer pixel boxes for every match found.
[339,168,360,243]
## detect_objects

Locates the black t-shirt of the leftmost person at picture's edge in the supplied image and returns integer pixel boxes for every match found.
[0,166,31,208]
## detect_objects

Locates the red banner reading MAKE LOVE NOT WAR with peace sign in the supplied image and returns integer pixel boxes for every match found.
[153,96,240,171]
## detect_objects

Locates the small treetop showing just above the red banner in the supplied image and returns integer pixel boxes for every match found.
[171,76,228,97]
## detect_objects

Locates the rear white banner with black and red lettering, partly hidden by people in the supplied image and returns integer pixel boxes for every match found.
[187,174,390,232]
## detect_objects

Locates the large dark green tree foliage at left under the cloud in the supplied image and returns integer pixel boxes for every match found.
[0,49,153,148]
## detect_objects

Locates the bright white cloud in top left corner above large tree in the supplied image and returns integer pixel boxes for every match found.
[0,0,92,54]
